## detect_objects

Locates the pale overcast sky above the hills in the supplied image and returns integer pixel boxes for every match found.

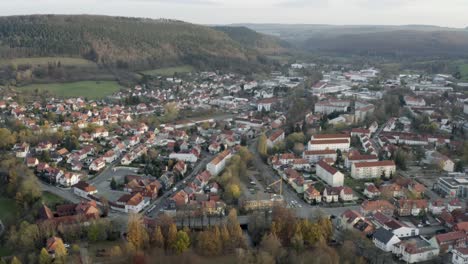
[0,0,468,27]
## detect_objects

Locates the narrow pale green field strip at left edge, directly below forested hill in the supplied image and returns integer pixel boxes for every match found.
[0,57,96,66]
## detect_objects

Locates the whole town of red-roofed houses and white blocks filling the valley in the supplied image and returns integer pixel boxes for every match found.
[0,62,468,264]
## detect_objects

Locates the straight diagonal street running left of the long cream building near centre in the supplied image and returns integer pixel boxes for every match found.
[143,154,214,218]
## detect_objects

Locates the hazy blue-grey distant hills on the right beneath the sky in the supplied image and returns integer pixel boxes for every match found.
[236,24,468,57]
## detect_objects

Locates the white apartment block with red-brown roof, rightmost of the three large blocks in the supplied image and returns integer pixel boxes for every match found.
[351,160,396,179]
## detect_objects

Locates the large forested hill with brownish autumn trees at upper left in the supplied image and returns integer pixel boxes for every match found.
[0,15,284,69]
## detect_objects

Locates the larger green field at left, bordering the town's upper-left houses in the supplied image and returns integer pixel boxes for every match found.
[18,81,122,99]
